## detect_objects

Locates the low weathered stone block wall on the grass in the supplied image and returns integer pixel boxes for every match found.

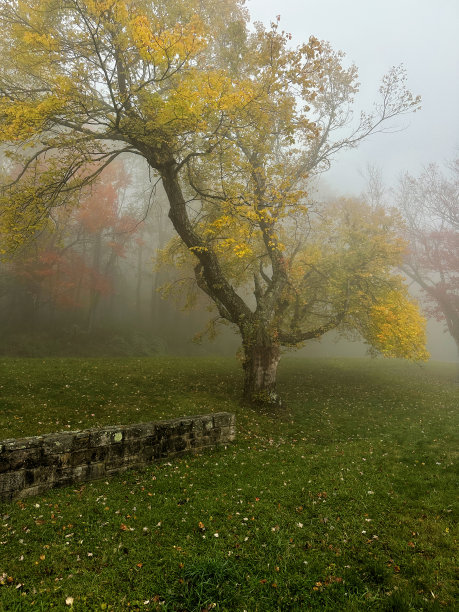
[0,412,236,501]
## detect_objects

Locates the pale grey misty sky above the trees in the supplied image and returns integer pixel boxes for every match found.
[247,0,459,195]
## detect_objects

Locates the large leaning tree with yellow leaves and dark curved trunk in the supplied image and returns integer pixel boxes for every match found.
[0,0,422,402]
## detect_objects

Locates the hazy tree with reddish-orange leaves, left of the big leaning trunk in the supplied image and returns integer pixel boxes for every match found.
[0,161,141,331]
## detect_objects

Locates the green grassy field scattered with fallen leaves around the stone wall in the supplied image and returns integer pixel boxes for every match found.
[0,358,459,612]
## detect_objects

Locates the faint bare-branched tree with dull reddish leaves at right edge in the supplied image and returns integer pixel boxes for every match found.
[396,159,459,366]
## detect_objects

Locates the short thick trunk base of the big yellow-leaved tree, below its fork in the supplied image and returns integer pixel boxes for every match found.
[243,342,281,406]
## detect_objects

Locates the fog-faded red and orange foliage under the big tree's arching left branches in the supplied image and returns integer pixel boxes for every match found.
[7,163,140,309]
